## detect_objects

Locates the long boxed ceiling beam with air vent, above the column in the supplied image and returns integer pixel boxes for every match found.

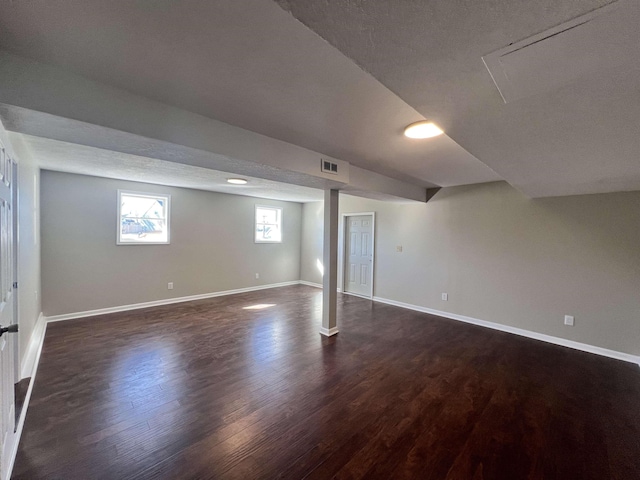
[0,50,425,201]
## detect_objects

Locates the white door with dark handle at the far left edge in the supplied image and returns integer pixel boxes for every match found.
[0,145,15,479]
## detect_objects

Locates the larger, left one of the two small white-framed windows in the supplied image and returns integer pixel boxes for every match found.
[117,190,171,245]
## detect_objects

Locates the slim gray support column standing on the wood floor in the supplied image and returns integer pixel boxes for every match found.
[320,190,338,337]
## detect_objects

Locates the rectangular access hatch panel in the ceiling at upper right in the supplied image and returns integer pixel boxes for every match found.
[482,0,640,103]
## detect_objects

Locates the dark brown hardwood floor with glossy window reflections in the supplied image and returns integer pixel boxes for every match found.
[13,286,640,480]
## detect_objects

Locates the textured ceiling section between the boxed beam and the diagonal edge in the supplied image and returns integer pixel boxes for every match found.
[0,0,500,191]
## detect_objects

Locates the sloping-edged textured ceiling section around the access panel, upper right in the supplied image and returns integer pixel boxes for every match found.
[277,0,640,196]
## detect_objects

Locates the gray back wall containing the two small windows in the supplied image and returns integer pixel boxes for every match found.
[41,171,302,316]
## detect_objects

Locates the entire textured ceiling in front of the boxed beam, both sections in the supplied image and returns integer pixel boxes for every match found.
[0,0,640,197]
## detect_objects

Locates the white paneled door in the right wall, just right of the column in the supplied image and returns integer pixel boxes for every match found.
[344,214,373,298]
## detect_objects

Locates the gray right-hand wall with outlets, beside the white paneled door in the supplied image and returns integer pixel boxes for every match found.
[302,182,640,355]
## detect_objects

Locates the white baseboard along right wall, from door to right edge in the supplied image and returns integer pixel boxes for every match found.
[373,297,640,365]
